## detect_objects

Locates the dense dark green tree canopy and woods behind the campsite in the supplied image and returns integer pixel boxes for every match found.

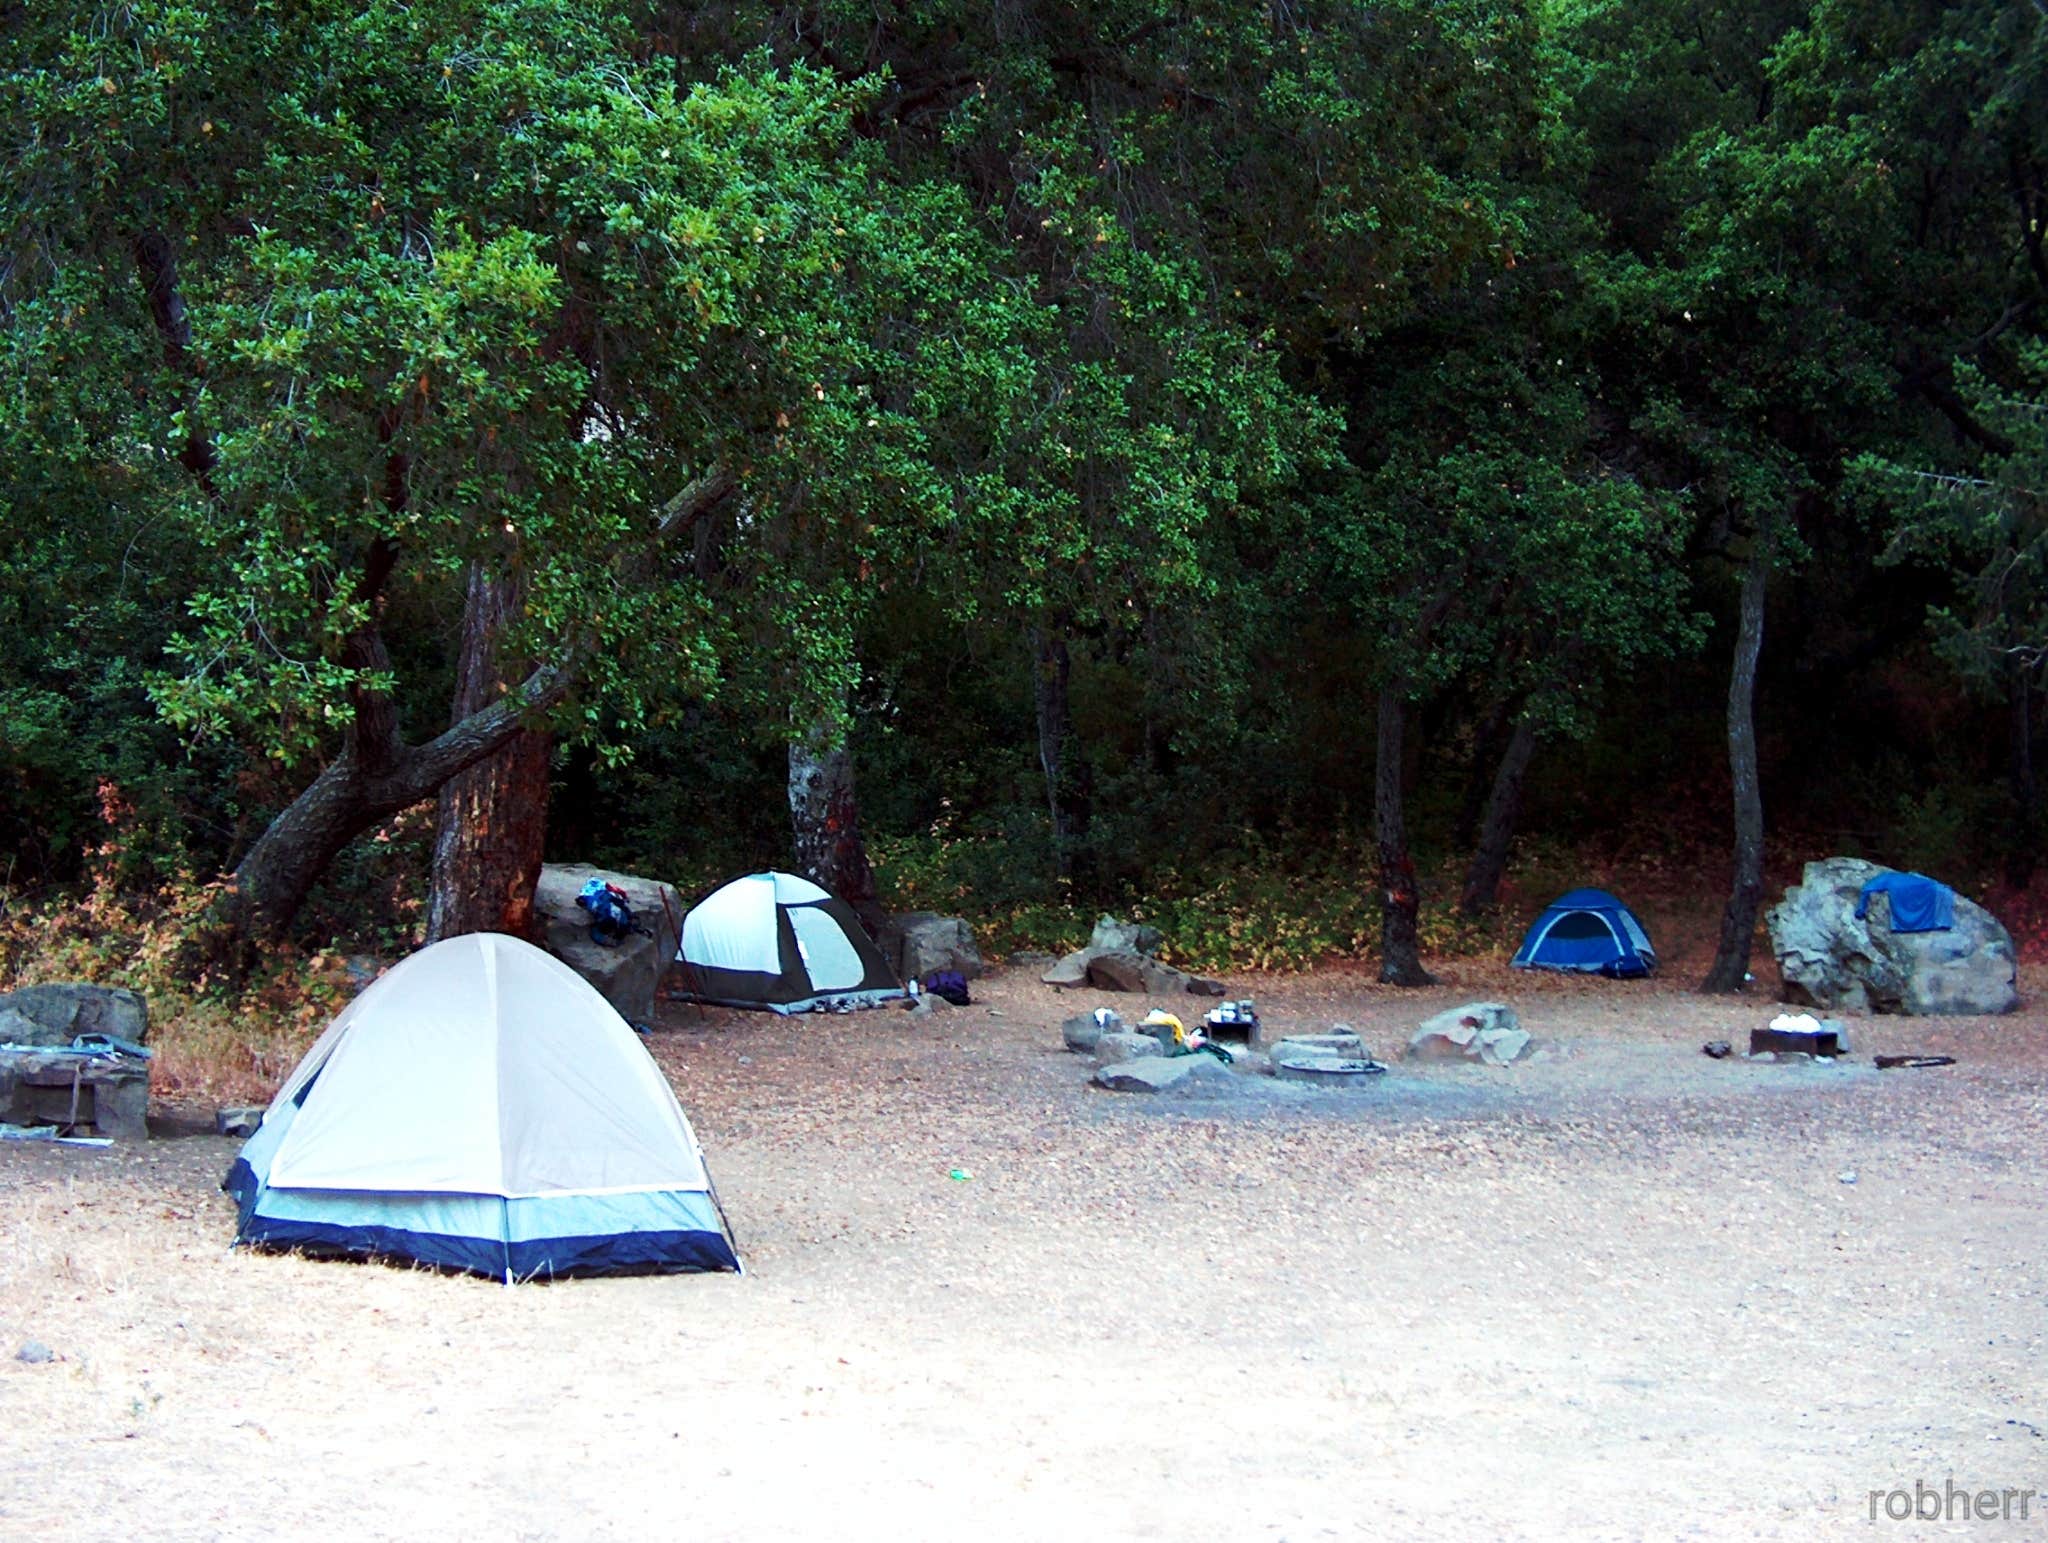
[0,0,2048,988]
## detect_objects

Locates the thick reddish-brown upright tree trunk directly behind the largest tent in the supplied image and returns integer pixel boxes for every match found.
[426,564,553,943]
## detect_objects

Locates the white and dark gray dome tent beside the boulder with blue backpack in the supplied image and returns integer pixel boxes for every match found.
[676,873,909,1012]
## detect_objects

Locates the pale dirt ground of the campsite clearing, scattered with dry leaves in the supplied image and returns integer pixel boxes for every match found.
[0,965,2048,1543]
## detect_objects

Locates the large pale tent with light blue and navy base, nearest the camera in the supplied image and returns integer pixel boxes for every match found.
[221,932,739,1281]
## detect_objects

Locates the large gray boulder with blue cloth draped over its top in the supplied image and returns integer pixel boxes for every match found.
[1763,857,2019,1014]
